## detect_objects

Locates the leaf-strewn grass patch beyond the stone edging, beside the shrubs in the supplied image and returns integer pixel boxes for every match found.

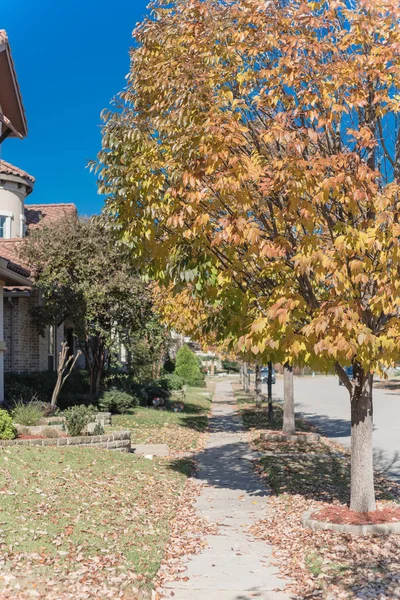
[111,380,215,453]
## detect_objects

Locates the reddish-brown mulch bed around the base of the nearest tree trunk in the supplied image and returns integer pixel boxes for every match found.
[311,506,400,525]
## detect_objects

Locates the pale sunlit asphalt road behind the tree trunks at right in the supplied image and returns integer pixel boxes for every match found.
[263,376,400,483]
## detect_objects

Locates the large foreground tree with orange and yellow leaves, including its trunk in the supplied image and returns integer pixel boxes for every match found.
[98,0,400,511]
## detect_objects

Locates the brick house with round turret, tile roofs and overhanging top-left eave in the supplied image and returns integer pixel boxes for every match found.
[0,30,76,402]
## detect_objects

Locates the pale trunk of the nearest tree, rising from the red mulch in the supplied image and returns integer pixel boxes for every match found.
[350,368,376,512]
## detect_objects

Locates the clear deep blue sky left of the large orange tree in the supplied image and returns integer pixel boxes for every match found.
[0,0,148,215]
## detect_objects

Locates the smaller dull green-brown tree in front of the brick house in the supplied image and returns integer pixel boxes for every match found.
[21,216,154,393]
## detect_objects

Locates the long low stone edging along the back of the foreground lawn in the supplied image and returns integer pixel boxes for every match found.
[0,431,131,452]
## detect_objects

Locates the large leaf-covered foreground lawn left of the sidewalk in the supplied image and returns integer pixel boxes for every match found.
[0,446,190,600]
